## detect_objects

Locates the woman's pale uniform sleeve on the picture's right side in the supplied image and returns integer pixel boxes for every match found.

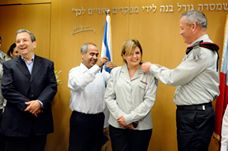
[125,75,157,124]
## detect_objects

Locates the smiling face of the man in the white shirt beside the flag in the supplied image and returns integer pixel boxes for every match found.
[82,44,99,68]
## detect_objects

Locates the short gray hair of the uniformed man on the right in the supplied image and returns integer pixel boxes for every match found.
[181,10,207,28]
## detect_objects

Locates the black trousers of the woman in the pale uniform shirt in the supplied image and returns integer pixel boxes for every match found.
[109,126,152,151]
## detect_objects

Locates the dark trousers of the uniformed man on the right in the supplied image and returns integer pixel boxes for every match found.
[176,104,215,151]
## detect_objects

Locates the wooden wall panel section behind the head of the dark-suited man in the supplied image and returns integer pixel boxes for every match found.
[0,3,51,58]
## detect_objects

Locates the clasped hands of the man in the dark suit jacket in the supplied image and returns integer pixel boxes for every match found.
[24,100,42,117]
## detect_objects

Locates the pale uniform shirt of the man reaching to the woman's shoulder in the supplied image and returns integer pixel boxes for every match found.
[150,35,219,105]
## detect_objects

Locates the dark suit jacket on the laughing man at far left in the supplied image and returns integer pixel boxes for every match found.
[1,55,57,137]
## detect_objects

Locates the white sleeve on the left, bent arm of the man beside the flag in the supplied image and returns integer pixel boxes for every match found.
[68,65,100,91]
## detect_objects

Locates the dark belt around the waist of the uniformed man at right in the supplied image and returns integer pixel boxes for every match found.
[177,102,212,111]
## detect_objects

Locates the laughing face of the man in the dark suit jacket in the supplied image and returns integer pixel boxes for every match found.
[16,32,36,57]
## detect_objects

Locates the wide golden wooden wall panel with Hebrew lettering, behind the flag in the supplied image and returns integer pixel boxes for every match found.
[49,0,226,151]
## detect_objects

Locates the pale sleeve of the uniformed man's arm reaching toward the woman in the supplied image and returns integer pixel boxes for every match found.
[150,49,209,86]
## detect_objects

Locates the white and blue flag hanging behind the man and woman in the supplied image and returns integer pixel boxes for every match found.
[101,14,112,72]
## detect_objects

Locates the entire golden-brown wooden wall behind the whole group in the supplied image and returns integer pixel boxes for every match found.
[0,0,227,151]
